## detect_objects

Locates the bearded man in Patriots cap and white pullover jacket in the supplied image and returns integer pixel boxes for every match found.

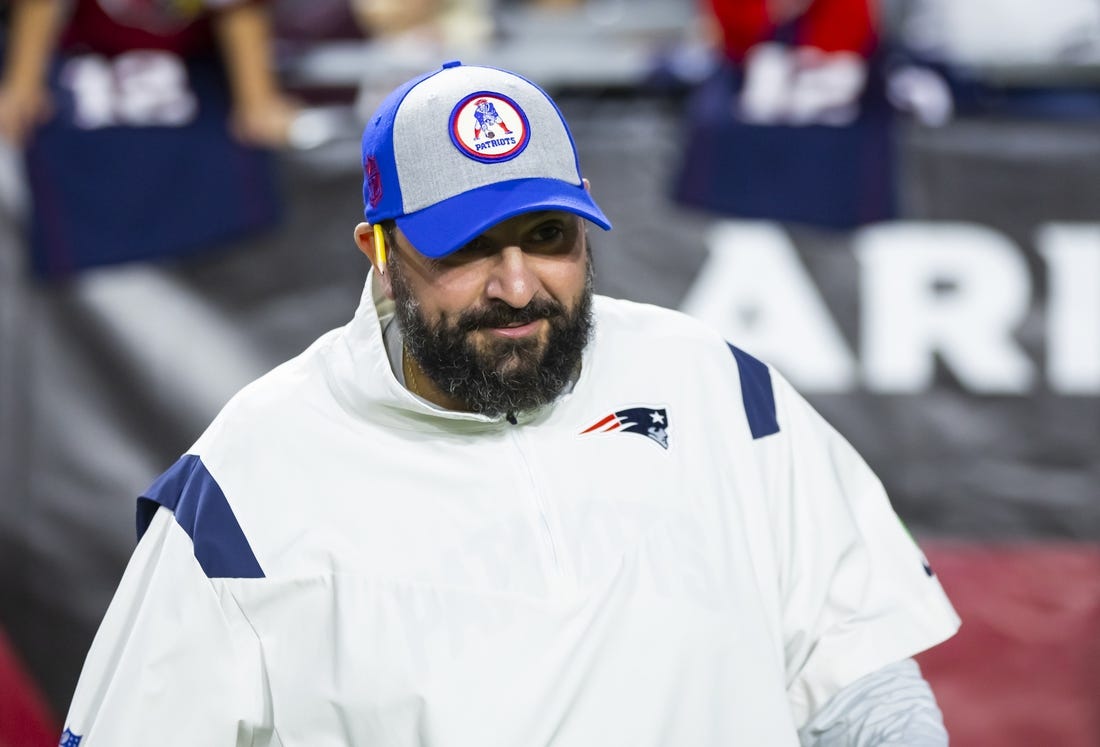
[66,63,958,747]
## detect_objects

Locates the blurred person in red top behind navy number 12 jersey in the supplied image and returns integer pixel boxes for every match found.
[673,0,897,229]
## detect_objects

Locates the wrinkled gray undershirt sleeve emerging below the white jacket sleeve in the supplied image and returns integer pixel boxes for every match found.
[799,659,947,747]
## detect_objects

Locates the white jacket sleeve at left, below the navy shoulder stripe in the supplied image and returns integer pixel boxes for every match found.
[65,497,277,747]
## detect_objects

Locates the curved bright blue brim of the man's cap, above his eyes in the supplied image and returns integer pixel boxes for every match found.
[396,179,612,259]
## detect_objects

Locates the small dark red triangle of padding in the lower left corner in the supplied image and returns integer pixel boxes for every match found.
[0,630,62,747]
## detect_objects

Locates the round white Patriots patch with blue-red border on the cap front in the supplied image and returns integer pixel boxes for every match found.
[451,91,530,163]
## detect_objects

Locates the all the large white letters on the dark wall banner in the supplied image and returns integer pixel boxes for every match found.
[682,220,1100,395]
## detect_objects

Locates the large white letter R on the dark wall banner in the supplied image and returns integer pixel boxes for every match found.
[855,222,1034,394]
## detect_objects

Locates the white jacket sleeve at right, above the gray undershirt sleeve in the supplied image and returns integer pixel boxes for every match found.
[759,372,959,727]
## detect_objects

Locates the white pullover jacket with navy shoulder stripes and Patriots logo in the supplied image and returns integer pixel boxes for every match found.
[65,281,958,747]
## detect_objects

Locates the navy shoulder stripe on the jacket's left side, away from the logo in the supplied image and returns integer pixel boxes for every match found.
[138,454,264,579]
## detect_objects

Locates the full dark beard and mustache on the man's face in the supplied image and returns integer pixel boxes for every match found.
[388,250,593,417]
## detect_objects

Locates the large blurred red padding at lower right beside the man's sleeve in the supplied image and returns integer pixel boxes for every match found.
[917,541,1100,747]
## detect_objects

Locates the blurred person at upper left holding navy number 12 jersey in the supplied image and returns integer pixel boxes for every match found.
[0,0,298,279]
